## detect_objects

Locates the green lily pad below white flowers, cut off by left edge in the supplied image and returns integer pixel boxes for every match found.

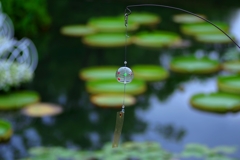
[0,91,40,110]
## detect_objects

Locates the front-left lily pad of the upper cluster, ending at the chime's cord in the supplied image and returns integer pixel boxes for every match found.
[82,33,131,47]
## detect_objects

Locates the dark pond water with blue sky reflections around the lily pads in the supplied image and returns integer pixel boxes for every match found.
[0,2,240,160]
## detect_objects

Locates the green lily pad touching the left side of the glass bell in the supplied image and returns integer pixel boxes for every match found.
[79,66,119,80]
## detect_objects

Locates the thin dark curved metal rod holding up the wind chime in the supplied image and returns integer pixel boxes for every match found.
[125,4,240,49]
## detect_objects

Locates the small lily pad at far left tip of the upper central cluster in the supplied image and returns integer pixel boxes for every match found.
[60,25,96,37]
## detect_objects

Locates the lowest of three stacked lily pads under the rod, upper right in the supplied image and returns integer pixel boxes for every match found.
[194,32,234,43]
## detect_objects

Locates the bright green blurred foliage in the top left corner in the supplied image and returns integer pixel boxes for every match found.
[1,0,51,37]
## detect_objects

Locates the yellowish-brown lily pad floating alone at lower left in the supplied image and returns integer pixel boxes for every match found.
[23,103,62,117]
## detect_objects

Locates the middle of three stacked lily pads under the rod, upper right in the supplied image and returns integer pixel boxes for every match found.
[181,22,229,35]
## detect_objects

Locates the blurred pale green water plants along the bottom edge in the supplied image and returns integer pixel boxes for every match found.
[22,142,237,160]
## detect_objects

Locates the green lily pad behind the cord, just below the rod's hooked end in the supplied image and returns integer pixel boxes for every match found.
[88,17,139,32]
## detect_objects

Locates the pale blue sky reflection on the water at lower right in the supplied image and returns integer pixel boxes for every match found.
[133,78,240,151]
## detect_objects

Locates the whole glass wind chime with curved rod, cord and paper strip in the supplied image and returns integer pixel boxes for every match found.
[112,4,240,148]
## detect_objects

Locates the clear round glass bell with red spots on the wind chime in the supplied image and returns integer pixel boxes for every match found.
[116,67,133,84]
